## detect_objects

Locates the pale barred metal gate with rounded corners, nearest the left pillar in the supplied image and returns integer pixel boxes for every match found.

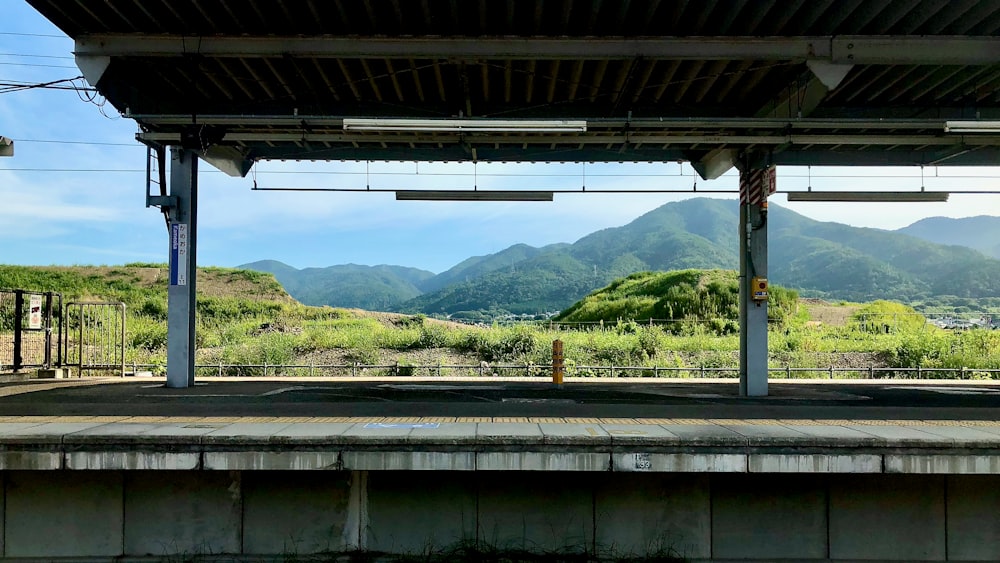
[63,302,125,377]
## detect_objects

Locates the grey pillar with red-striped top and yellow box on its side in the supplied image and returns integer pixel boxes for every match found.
[739,167,774,397]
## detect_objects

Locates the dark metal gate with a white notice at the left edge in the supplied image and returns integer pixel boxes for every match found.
[0,289,63,373]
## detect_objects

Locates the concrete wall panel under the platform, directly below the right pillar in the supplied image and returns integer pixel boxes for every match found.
[712,474,827,560]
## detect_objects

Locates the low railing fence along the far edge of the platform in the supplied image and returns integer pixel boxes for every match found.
[111,363,1000,380]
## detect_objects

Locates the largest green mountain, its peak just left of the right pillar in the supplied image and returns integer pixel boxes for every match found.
[401,198,1000,314]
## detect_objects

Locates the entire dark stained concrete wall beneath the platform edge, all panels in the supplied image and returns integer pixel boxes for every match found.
[0,471,1000,561]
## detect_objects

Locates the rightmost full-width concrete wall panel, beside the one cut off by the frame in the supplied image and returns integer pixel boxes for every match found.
[830,475,945,561]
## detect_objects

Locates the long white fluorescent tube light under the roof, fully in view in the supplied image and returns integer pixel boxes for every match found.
[344,118,587,133]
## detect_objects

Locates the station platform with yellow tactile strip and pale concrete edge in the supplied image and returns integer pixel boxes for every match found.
[0,378,1000,474]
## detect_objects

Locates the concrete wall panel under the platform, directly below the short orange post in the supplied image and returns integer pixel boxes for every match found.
[477,472,594,551]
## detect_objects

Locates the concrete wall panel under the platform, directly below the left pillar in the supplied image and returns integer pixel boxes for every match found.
[125,471,241,556]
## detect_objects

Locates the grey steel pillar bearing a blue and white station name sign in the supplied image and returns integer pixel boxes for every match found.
[167,147,198,387]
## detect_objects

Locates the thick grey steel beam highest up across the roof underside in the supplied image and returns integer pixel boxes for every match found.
[74,34,1000,65]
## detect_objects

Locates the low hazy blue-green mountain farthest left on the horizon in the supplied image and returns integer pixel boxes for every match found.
[240,260,434,311]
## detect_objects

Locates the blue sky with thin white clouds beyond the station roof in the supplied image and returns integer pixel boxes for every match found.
[0,0,1000,272]
